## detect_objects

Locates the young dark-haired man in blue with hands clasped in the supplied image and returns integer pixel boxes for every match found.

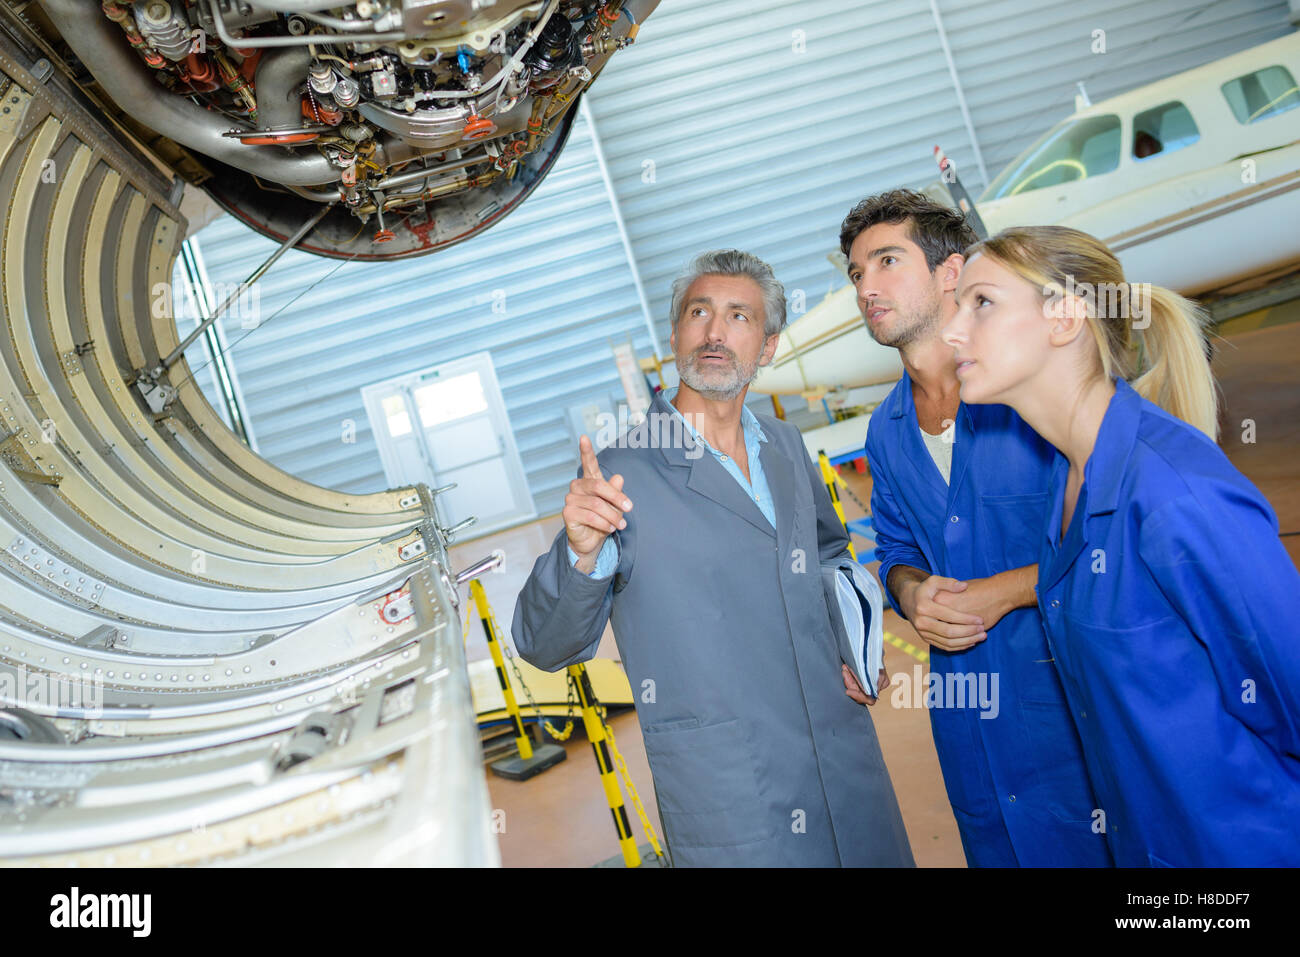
[840,190,1112,867]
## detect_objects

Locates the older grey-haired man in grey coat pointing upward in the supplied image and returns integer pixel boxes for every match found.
[512,250,913,866]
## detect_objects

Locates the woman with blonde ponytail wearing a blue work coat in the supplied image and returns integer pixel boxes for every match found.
[943,226,1300,866]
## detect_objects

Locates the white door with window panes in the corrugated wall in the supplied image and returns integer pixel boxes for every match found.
[361,352,537,541]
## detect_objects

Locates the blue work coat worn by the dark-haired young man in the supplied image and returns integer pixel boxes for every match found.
[866,374,1110,867]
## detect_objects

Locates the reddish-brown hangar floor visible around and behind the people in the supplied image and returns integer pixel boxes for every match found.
[441,300,1300,867]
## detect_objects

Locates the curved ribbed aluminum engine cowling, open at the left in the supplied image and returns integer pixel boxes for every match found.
[0,33,499,866]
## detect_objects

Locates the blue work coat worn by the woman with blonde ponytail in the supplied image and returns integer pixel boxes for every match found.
[1034,380,1300,867]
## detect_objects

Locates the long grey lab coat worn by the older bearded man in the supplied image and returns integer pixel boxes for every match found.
[512,395,913,866]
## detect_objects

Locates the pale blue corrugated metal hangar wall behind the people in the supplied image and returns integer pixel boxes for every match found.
[178,0,1291,514]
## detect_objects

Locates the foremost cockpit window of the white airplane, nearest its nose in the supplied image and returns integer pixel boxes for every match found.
[980,113,1119,200]
